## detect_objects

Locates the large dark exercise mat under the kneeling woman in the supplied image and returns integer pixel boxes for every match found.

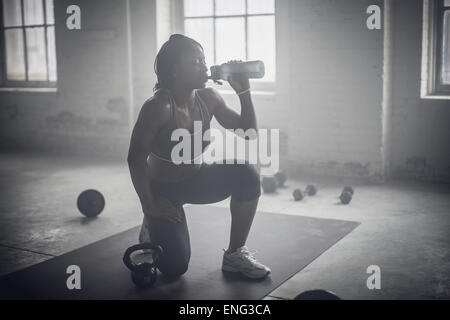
[0,206,359,300]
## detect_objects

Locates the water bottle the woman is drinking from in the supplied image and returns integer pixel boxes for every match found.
[209,60,265,81]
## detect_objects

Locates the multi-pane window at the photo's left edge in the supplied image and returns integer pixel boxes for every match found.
[0,0,57,87]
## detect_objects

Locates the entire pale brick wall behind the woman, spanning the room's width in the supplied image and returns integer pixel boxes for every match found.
[0,0,450,182]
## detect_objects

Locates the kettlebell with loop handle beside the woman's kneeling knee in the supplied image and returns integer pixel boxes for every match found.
[123,243,163,288]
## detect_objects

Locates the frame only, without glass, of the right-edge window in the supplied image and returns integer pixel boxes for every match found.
[421,0,450,99]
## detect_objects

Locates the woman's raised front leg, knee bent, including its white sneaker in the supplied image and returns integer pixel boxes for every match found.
[182,163,271,279]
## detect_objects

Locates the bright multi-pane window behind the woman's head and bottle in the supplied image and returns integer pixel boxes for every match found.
[183,0,275,88]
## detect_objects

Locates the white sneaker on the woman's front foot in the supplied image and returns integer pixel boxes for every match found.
[222,246,270,279]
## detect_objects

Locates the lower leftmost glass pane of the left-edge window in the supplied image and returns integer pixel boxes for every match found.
[5,29,25,80]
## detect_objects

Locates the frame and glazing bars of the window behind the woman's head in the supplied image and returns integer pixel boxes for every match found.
[179,0,277,92]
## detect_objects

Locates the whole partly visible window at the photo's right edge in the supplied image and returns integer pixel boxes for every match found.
[421,0,450,99]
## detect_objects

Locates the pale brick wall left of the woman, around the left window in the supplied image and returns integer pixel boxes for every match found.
[0,0,156,158]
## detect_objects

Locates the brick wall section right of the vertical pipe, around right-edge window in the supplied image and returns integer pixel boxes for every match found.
[391,0,450,181]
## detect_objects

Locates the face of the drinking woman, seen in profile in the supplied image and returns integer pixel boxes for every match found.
[174,45,208,89]
